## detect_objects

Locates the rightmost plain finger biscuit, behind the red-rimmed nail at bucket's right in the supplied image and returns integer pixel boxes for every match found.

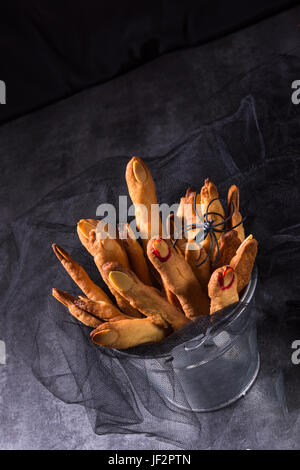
[230,235,258,293]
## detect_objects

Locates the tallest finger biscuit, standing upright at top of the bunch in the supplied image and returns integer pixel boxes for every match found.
[125,157,162,253]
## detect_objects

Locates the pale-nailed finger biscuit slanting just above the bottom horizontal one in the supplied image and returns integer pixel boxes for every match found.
[103,263,189,330]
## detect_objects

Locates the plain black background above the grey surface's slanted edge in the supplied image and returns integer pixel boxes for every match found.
[0,0,298,123]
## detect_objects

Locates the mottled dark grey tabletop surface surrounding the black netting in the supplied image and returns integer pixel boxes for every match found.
[0,4,300,449]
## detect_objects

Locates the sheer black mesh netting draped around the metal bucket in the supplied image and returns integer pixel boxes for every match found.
[5,57,300,448]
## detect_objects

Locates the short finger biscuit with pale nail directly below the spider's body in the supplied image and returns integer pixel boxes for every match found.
[184,242,211,292]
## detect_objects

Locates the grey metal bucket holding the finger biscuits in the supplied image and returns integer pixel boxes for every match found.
[119,268,260,412]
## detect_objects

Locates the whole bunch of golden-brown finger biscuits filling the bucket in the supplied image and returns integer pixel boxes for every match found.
[53,157,257,349]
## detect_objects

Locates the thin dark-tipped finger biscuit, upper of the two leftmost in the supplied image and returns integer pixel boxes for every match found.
[52,243,112,303]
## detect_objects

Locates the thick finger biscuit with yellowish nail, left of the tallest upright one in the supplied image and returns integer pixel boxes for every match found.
[77,219,141,318]
